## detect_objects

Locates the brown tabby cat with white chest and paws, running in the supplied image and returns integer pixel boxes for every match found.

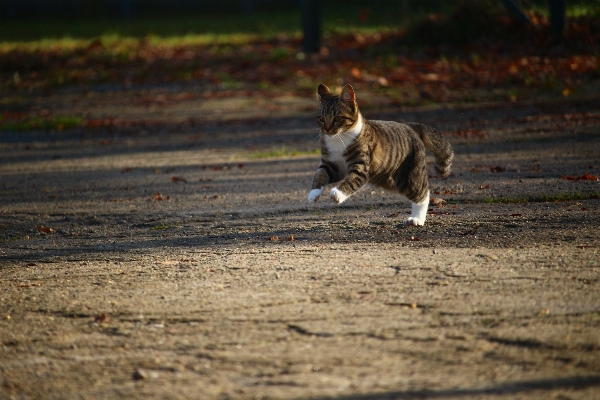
[308,84,454,226]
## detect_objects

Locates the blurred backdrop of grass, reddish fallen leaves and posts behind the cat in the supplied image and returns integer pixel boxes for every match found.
[0,0,600,129]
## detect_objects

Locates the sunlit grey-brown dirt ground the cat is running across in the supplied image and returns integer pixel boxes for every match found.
[0,89,600,399]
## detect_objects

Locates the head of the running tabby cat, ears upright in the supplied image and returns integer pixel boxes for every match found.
[317,84,359,135]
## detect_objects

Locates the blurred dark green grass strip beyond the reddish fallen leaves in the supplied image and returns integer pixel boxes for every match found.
[0,0,600,40]
